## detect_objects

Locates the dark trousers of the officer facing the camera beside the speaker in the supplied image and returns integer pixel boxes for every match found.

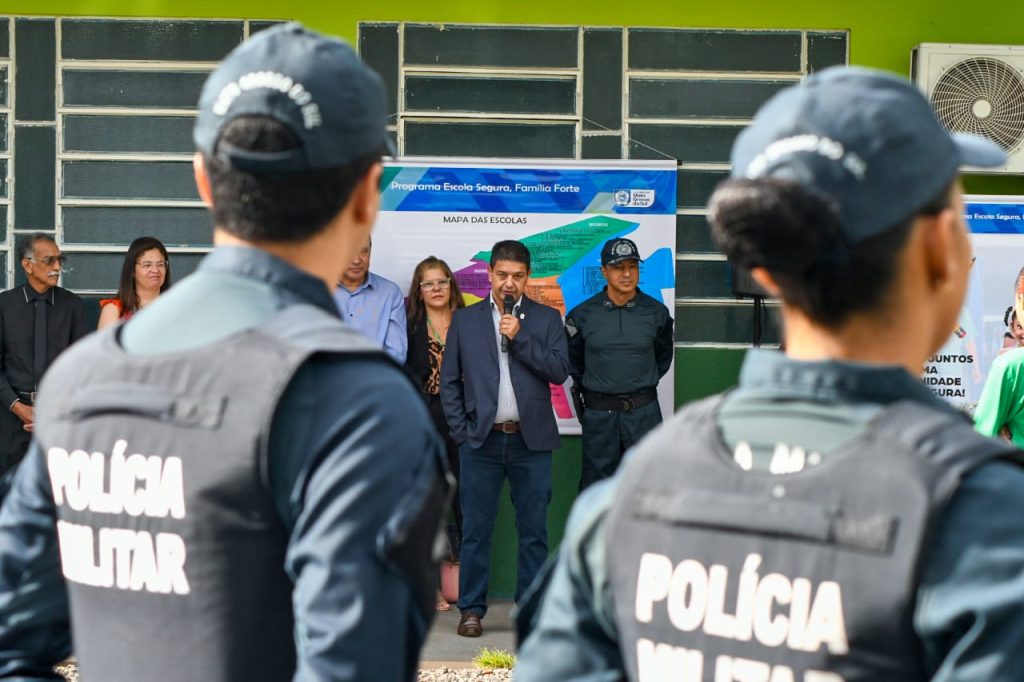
[580,400,662,491]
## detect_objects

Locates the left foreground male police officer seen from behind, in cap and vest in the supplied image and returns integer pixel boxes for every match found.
[0,24,445,682]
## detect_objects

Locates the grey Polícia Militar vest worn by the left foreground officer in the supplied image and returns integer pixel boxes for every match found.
[36,305,389,682]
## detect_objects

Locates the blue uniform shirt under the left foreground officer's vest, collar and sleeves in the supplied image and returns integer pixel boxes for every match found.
[0,247,441,680]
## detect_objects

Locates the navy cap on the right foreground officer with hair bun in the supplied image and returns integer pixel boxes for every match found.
[731,67,1006,244]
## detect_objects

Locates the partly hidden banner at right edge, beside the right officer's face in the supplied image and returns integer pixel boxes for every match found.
[924,196,1024,413]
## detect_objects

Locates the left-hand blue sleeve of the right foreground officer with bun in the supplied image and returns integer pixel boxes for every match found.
[515,478,625,682]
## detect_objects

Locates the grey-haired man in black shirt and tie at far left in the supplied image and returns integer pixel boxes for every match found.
[0,232,88,474]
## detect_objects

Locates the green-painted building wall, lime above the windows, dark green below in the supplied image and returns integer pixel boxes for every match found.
[16,0,1024,595]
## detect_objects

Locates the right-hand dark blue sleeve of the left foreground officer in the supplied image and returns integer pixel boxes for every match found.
[268,358,443,682]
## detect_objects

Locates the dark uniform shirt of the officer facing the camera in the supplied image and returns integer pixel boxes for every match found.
[565,288,674,394]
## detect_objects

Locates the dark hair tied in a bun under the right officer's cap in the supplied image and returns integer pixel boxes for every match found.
[709,177,952,328]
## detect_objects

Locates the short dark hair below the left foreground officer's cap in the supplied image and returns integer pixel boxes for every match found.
[203,116,383,243]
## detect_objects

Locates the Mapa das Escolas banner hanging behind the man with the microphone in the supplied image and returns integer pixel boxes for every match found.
[371,159,677,434]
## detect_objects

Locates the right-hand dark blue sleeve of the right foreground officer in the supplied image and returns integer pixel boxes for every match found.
[914,462,1024,682]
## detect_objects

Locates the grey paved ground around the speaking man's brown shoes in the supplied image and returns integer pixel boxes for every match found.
[420,601,515,668]
